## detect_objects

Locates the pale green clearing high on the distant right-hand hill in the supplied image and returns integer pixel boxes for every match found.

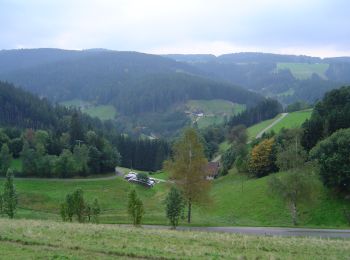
[277,63,329,79]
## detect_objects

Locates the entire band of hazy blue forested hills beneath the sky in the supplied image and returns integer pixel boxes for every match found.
[0,48,350,134]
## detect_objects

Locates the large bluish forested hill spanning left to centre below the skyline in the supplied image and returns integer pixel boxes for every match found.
[0,49,264,134]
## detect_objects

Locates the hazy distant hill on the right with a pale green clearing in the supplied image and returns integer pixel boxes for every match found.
[165,52,350,104]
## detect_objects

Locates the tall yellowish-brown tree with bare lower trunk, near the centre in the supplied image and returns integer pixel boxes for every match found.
[165,128,210,223]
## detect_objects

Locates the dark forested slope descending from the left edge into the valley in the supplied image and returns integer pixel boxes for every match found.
[0,82,170,175]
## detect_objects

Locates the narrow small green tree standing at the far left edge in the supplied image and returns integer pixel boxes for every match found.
[3,169,18,218]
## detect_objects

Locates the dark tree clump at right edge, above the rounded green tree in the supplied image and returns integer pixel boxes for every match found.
[302,86,350,150]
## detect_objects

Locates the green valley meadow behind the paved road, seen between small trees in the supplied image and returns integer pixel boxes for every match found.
[0,170,347,228]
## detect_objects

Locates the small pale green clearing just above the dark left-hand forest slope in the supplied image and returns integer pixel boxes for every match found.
[60,99,117,120]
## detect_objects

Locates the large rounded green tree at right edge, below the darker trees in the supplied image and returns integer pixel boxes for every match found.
[310,128,350,194]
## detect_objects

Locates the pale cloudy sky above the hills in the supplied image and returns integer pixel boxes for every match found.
[0,0,350,57]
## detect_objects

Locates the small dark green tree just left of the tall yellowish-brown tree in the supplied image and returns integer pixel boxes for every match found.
[165,187,185,229]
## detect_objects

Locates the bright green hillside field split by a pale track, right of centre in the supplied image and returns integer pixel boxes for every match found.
[248,109,312,140]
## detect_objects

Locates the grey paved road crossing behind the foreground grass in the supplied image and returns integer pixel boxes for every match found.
[138,225,350,239]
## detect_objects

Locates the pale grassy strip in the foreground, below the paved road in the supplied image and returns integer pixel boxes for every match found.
[0,219,350,259]
